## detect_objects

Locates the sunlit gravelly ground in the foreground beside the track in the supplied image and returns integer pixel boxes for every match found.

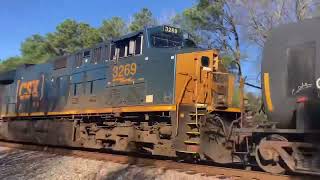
[0,147,228,180]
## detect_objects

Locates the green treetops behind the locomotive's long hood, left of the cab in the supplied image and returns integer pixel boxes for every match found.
[0,8,156,71]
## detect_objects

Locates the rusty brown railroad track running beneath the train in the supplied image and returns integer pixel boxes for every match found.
[0,141,313,180]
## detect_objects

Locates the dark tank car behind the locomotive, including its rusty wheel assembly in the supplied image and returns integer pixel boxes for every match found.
[256,18,320,174]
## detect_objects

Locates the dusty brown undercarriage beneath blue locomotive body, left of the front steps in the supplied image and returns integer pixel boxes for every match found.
[1,112,178,156]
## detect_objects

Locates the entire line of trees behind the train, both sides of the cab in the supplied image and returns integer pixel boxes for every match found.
[0,0,320,71]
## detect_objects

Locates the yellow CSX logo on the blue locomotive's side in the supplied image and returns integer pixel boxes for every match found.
[19,80,40,100]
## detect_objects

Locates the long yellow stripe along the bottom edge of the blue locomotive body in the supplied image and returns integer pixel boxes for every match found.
[3,105,176,117]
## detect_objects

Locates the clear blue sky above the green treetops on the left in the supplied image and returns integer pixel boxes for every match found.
[0,0,195,59]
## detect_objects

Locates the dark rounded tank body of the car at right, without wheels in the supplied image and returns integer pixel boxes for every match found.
[262,18,320,129]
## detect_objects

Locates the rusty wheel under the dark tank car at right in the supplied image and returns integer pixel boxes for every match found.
[255,135,288,174]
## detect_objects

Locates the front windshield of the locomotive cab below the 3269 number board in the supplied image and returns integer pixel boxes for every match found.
[151,32,183,48]
